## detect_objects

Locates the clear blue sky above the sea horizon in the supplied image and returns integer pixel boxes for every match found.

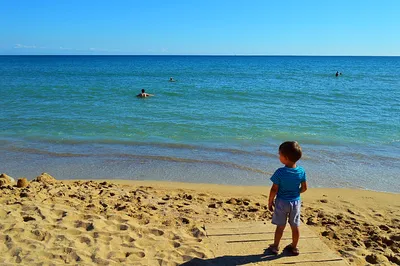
[0,0,400,55]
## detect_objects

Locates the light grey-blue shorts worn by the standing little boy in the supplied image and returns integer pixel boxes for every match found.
[272,199,301,226]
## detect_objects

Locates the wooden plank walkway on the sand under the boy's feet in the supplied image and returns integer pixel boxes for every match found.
[185,222,348,266]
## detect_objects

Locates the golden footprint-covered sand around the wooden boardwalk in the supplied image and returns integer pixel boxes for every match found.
[0,174,400,265]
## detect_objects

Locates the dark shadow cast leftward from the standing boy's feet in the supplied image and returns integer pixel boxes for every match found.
[181,249,288,266]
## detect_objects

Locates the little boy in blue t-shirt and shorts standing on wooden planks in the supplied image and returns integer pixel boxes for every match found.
[268,141,307,255]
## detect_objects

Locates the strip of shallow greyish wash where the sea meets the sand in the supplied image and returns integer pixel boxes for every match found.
[0,145,400,193]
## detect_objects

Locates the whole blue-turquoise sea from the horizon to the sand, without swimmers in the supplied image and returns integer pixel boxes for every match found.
[0,56,400,193]
